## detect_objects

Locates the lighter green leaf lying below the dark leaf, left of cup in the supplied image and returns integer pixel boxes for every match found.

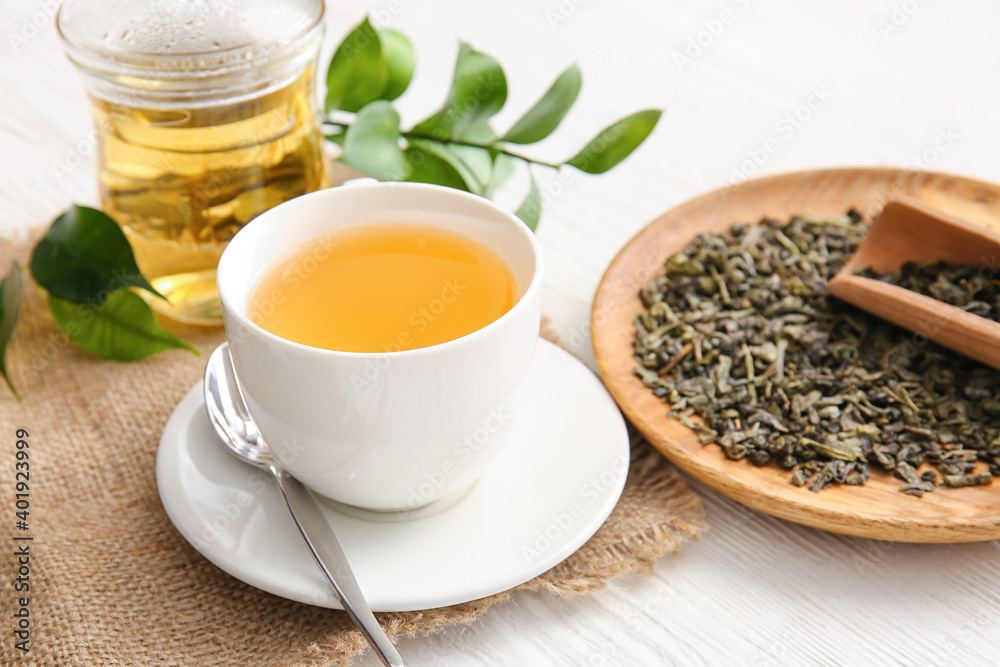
[49,290,199,361]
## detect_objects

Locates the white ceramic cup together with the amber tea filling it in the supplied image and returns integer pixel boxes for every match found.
[218,183,542,511]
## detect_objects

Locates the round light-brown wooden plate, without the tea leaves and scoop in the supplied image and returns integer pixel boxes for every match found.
[591,168,1000,542]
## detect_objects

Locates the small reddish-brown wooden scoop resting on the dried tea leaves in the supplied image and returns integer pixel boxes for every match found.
[827,198,1000,369]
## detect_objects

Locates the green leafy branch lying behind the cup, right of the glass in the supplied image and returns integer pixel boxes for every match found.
[324,19,662,230]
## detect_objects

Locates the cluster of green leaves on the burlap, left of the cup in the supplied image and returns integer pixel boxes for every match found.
[0,206,198,399]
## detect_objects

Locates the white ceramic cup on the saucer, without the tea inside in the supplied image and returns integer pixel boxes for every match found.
[217,183,542,511]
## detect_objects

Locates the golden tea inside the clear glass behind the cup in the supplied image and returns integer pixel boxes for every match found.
[90,67,328,324]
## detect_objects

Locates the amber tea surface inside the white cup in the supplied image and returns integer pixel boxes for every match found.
[249,224,516,352]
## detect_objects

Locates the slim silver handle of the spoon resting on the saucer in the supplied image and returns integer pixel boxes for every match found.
[268,465,406,667]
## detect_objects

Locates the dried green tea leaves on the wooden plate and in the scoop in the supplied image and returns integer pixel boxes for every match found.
[633,211,1000,497]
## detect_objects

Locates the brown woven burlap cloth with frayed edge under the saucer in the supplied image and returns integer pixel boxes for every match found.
[0,237,704,666]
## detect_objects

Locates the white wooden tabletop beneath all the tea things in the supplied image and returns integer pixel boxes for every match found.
[0,0,1000,666]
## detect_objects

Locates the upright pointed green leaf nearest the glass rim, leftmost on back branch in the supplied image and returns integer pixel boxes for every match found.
[325,18,389,113]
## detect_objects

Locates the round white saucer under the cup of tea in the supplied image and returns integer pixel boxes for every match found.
[156,340,629,611]
